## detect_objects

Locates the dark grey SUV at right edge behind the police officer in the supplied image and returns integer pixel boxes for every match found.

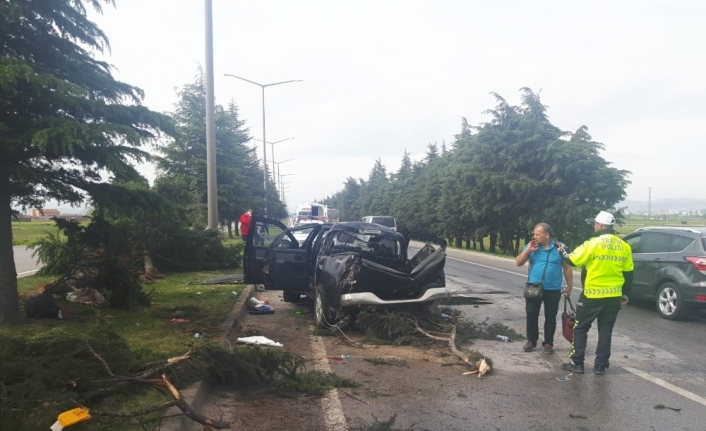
[623,226,706,320]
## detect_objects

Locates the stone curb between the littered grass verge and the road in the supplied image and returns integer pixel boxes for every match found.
[157,284,257,431]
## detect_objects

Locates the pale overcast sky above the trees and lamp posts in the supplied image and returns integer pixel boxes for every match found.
[85,0,706,213]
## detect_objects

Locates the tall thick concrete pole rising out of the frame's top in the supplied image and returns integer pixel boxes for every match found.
[206,0,218,229]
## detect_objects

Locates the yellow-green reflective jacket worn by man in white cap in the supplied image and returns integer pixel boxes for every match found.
[569,234,633,298]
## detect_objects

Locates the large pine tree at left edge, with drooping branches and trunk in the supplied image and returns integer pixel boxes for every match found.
[0,0,171,325]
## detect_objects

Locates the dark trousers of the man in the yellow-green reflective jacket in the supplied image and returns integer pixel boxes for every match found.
[570,293,621,368]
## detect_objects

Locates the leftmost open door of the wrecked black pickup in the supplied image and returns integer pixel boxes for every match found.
[243,216,287,284]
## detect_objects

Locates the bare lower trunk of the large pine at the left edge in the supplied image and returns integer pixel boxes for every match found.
[0,166,22,326]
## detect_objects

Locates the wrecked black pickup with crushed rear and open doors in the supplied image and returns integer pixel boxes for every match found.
[243,217,451,326]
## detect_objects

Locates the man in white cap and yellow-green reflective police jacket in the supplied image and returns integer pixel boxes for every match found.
[560,211,633,375]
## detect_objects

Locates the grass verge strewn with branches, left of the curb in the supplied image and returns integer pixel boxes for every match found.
[0,271,244,431]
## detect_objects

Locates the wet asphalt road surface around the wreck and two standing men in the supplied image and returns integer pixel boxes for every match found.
[197,246,706,431]
